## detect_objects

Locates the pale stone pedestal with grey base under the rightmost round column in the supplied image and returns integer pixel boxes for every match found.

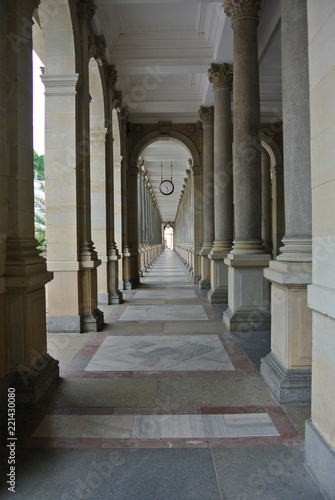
[261,260,312,404]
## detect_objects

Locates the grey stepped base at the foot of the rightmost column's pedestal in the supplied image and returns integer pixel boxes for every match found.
[261,352,312,405]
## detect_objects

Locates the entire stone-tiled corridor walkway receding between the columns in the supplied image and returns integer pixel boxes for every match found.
[0,251,322,500]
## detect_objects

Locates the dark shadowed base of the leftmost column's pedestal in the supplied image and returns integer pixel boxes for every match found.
[14,354,59,406]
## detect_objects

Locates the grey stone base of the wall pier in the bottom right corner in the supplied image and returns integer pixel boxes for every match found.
[305,419,335,500]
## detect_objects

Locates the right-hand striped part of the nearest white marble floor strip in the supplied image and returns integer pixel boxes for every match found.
[131,413,279,439]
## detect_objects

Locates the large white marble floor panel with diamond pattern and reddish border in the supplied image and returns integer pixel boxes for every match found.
[85,335,234,372]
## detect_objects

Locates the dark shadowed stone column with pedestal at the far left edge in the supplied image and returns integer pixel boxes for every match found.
[0,0,58,406]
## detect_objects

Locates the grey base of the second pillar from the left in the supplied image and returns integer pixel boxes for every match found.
[47,309,104,333]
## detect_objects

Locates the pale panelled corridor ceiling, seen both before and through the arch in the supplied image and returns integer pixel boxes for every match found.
[93,0,282,221]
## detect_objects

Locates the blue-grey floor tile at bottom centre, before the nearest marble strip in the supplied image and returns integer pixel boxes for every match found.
[88,449,220,500]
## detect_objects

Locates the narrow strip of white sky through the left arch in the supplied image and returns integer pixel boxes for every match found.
[33,51,45,155]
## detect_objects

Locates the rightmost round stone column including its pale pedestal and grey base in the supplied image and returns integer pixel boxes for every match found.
[261,0,312,404]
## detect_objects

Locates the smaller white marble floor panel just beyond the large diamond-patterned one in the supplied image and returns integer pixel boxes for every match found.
[119,305,208,321]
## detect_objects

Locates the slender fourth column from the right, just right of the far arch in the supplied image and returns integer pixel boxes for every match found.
[199,106,214,290]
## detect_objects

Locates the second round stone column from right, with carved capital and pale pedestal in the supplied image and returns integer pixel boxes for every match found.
[223,0,270,331]
